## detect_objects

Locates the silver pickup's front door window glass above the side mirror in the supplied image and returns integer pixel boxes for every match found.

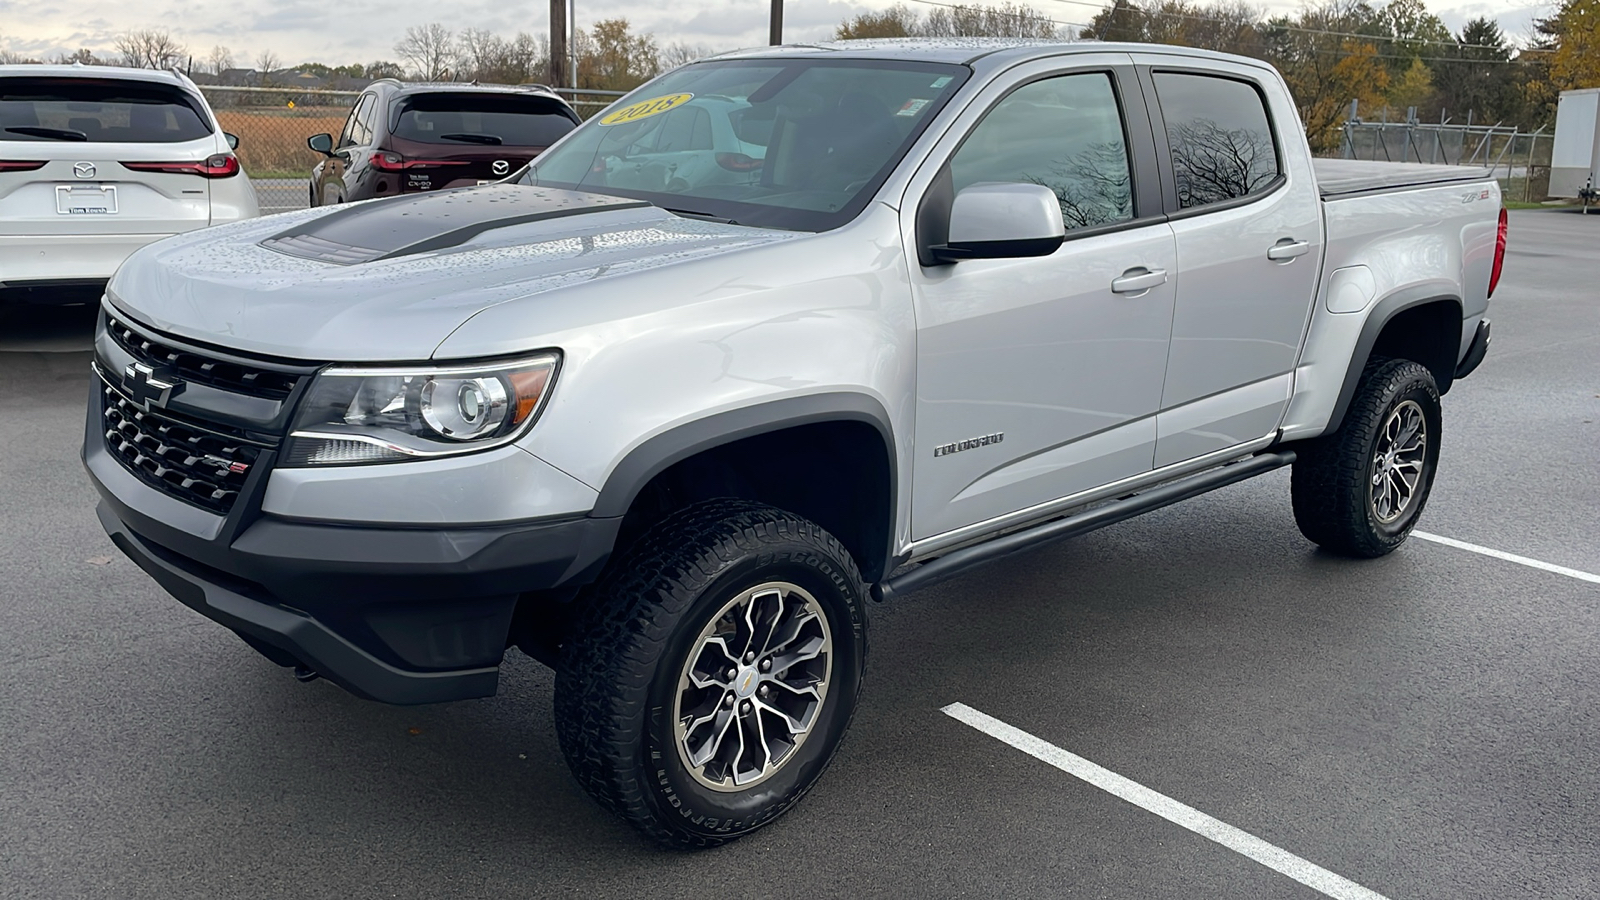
[950,72,1133,231]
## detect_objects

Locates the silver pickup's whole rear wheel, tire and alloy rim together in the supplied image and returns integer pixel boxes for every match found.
[1290,359,1442,559]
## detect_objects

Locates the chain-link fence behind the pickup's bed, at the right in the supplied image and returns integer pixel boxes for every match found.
[1336,117,1554,202]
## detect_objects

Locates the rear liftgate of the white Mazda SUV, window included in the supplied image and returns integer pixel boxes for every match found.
[0,77,227,235]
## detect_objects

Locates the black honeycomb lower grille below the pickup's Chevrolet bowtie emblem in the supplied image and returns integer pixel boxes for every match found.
[101,383,261,516]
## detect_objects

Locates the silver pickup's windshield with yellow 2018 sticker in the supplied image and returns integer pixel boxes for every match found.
[522,59,968,231]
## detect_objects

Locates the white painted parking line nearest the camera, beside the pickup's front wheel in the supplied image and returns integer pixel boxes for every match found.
[942,703,1387,900]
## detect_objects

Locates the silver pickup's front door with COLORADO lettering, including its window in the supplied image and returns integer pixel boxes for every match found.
[912,68,1178,540]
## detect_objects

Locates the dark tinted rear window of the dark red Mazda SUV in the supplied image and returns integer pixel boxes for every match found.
[394,93,578,147]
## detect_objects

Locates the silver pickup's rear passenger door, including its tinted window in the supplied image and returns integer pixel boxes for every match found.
[1134,56,1323,468]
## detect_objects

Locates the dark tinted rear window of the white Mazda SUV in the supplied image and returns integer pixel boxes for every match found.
[0,78,211,144]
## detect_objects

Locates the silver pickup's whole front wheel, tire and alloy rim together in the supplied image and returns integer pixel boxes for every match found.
[555,501,866,847]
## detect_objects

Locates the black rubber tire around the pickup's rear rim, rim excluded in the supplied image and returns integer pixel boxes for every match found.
[1290,359,1440,559]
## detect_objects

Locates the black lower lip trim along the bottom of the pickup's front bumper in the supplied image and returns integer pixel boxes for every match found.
[98,503,499,705]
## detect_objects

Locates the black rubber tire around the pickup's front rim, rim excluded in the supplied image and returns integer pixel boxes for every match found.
[555,500,867,849]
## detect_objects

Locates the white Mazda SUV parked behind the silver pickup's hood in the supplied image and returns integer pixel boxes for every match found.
[0,66,259,303]
